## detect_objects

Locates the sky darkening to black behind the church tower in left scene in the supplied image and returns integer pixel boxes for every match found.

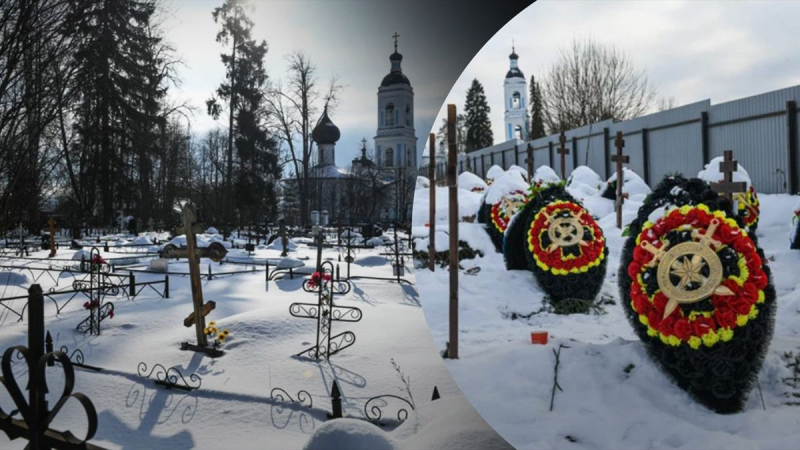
[162,0,519,171]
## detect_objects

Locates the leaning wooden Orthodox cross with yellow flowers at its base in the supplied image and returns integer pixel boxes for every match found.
[161,203,228,357]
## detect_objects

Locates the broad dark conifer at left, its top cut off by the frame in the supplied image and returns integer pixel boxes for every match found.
[68,0,164,225]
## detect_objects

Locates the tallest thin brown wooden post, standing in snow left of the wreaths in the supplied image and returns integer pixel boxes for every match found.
[447,105,459,359]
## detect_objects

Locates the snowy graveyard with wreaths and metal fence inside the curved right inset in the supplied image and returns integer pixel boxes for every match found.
[412,87,800,449]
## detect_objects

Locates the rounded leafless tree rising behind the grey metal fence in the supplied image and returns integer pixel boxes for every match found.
[542,40,655,133]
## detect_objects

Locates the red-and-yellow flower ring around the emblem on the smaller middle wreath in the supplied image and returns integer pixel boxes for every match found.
[528,201,606,275]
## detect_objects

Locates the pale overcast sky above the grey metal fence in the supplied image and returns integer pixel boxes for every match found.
[428,0,800,156]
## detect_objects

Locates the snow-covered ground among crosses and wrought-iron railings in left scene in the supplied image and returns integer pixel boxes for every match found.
[0,234,508,449]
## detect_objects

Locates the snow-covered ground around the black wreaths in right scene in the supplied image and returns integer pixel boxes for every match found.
[413,167,800,449]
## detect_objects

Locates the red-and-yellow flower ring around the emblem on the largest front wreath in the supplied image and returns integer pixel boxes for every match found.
[628,205,768,349]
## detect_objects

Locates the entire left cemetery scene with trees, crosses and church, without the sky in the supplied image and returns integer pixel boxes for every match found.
[0,0,510,450]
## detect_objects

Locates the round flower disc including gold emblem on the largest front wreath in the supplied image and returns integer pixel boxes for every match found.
[628,204,768,350]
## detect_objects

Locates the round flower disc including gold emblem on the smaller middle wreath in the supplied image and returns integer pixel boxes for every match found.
[527,200,606,275]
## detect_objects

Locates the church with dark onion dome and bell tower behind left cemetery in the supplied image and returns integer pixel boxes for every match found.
[281,33,417,225]
